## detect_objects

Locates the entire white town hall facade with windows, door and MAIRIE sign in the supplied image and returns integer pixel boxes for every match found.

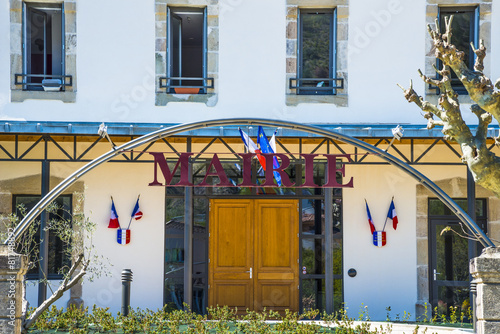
[0,0,500,320]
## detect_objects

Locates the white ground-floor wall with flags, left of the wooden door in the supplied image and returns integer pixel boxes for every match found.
[83,163,165,313]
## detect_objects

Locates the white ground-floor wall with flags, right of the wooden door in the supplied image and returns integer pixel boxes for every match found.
[343,166,466,320]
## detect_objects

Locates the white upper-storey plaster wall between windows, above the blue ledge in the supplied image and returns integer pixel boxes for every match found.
[0,0,434,124]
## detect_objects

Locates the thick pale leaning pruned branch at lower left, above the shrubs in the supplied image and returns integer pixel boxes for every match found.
[23,254,90,332]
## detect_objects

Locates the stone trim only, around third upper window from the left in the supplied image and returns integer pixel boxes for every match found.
[285,0,349,107]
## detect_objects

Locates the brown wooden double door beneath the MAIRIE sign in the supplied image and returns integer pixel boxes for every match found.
[209,199,299,313]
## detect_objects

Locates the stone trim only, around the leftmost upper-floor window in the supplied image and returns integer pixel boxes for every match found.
[10,0,77,102]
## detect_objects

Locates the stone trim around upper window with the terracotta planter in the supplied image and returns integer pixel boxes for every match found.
[155,0,219,107]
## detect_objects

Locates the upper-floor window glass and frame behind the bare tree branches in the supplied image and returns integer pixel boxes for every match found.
[437,7,479,94]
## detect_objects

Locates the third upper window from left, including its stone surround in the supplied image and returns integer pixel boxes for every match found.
[285,0,349,107]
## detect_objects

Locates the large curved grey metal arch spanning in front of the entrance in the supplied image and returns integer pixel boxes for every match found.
[5,118,495,247]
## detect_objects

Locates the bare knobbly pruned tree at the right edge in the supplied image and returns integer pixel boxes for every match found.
[398,16,500,197]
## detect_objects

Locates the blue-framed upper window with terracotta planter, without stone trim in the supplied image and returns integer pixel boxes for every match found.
[160,7,213,94]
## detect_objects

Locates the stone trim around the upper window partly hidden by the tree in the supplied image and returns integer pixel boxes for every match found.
[423,0,492,104]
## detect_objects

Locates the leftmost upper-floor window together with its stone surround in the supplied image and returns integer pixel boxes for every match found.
[10,0,76,102]
